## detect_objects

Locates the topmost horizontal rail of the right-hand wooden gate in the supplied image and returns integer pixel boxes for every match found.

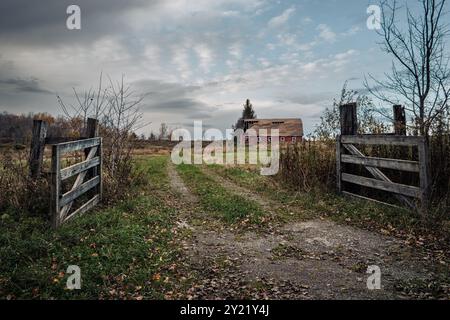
[341,135,424,146]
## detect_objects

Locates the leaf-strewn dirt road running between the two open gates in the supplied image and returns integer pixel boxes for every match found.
[168,165,433,299]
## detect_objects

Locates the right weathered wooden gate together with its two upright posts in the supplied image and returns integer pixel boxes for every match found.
[336,104,430,214]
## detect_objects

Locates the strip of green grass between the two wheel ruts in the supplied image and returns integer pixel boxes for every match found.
[177,165,264,223]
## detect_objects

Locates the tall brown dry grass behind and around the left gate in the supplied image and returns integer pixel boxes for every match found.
[0,142,149,217]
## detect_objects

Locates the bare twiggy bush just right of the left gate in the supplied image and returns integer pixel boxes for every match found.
[58,76,148,200]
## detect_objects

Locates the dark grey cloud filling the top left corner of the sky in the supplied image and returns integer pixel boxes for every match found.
[0,0,161,46]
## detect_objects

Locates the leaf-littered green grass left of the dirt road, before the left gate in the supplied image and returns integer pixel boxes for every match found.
[0,157,179,299]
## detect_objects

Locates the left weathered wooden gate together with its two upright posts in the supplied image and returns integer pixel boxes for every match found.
[30,119,102,228]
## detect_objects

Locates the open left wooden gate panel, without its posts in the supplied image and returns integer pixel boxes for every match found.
[51,138,102,227]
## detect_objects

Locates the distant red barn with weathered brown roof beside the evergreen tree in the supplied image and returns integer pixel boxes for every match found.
[244,119,303,143]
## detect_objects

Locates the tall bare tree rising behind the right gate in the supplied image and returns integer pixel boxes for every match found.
[365,0,450,135]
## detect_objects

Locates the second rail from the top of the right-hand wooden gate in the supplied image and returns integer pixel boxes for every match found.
[341,154,419,172]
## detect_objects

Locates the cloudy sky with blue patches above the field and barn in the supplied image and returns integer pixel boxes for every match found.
[0,0,400,133]
